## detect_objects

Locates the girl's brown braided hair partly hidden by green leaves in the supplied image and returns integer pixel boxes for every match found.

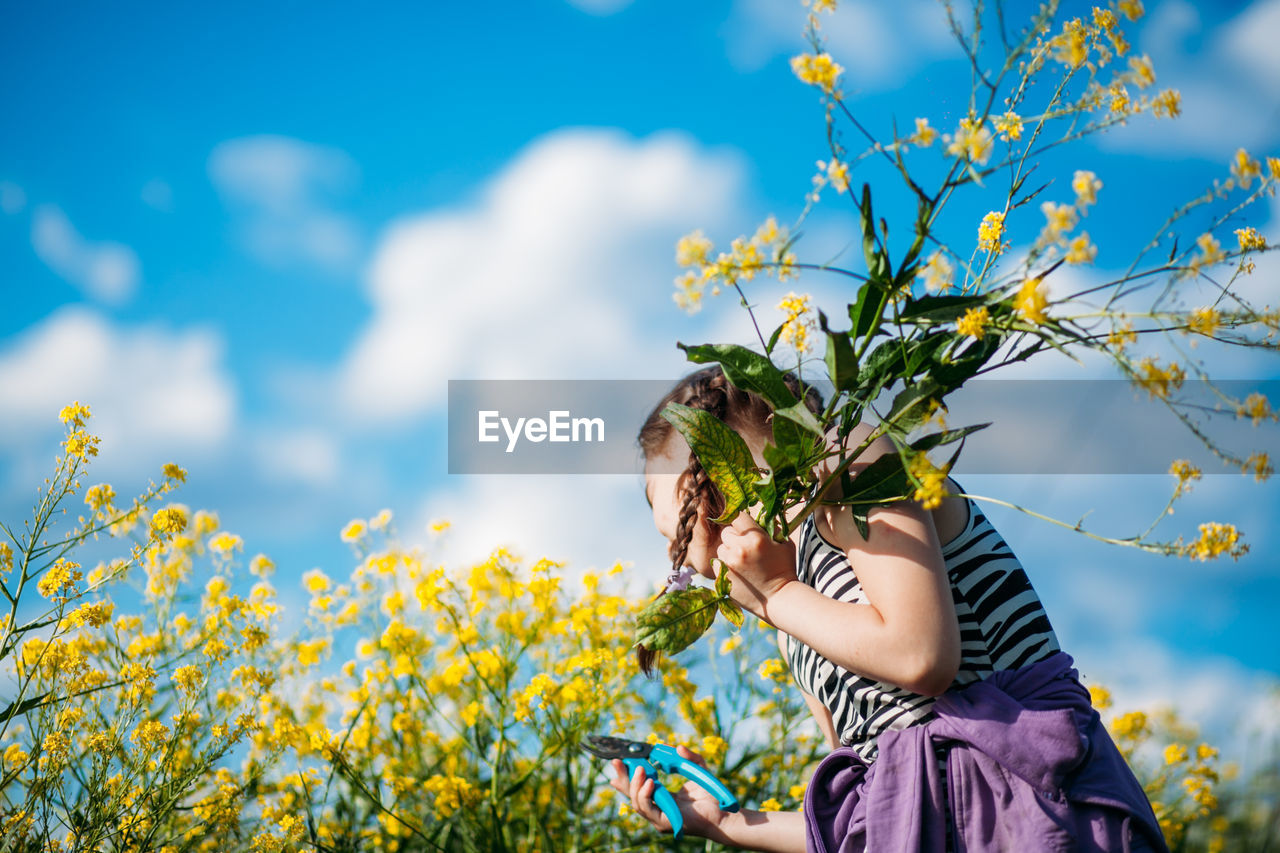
[636,364,823,675]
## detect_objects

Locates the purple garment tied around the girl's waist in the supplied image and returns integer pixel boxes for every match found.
[804,652,1169,853]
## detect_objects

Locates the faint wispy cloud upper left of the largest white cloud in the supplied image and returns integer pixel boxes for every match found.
[209,134,362,272]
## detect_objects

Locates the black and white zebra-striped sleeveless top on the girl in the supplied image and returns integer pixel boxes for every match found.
[787,489,1059,761]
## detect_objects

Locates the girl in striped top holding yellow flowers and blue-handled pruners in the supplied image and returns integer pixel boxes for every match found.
[612,365,1166,853]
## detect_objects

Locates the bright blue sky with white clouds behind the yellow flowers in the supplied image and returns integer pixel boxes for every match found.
[0,0,1280,758]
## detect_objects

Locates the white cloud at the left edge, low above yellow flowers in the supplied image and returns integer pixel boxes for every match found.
[0,306,236,482]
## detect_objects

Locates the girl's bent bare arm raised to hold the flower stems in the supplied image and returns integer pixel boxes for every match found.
[717,427,960,695]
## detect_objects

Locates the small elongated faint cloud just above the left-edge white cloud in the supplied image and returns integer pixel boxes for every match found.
[31,204,141,305]
